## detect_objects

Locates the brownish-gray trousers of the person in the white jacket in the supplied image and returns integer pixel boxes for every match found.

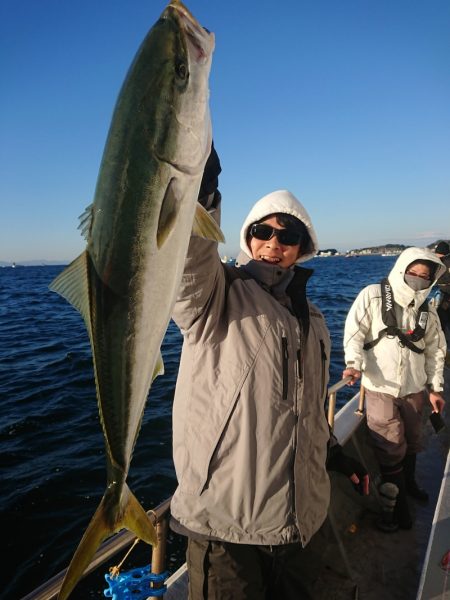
[365,390,426,466]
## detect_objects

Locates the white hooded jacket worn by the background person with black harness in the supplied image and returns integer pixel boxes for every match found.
[344,248,446,398]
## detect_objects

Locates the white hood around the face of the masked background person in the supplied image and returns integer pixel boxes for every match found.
[388,248,445,307]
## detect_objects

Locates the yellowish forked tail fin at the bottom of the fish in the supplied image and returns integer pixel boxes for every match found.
[58,484,157,600]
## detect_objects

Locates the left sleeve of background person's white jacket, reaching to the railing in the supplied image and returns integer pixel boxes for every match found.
[344,288,372,371]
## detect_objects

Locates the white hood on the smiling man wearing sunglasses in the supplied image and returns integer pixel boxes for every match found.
[240,190,319,263]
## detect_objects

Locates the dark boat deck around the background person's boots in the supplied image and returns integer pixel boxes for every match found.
[164,369,450,600]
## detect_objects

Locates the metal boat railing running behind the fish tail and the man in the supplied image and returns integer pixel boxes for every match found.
[22,377,364,600]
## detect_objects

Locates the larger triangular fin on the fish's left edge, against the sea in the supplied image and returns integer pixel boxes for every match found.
[49,251,91,335]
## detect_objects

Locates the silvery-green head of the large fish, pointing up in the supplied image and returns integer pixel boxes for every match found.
[150,0,215,176]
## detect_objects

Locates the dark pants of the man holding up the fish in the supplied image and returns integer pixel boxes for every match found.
[187,539,320,600]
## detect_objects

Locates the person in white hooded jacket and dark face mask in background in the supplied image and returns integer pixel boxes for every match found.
[343,248,446,531]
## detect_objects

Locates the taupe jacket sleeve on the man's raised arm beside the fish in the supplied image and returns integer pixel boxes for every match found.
[172,199,225,333]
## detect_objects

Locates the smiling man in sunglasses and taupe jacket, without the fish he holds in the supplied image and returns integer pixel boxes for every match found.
[171,148,368,600]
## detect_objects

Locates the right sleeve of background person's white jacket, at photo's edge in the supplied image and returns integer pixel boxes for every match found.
[424,306,447,392]
